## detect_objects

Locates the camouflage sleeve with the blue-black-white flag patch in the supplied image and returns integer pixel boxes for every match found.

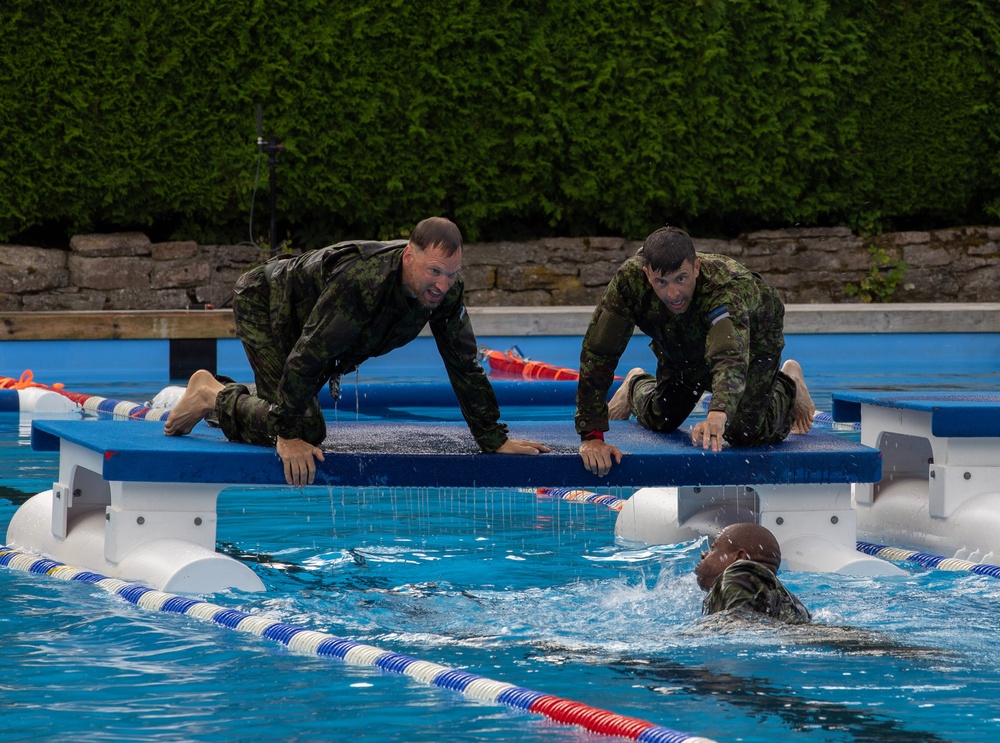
[705,291,750,420]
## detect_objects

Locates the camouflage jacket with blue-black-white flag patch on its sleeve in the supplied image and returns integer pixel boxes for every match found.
[576,253,785,434]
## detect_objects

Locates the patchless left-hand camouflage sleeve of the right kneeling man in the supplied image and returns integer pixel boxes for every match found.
[574,264,641,436]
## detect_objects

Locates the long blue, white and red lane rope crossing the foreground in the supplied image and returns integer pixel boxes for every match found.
[0,547,715,743]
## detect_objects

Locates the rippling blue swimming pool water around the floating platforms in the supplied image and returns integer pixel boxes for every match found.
[0,337,1000,742]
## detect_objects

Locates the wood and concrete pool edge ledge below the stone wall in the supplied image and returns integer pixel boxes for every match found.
[0,302,1000,341]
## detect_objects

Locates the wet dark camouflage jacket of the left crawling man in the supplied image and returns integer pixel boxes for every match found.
[265,240,507,451]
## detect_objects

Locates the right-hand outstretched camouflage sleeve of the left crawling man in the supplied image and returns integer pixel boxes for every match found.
[430,293,507,452]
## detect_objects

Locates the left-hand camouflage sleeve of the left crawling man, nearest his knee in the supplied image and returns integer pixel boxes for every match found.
[270,269,377,438]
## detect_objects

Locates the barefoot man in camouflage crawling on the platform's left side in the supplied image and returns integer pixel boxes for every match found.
[164,217,549,485]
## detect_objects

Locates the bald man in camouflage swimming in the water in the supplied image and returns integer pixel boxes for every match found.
[694,524,811,624]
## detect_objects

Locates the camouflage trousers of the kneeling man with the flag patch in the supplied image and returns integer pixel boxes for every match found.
[628,355,795,446]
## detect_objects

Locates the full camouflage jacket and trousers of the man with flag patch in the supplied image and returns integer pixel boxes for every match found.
[576,253,795,446]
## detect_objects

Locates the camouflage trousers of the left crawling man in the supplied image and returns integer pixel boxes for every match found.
[215,268,326,446]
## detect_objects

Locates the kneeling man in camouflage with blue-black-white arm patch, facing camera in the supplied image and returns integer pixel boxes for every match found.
[576,227,815,475]
